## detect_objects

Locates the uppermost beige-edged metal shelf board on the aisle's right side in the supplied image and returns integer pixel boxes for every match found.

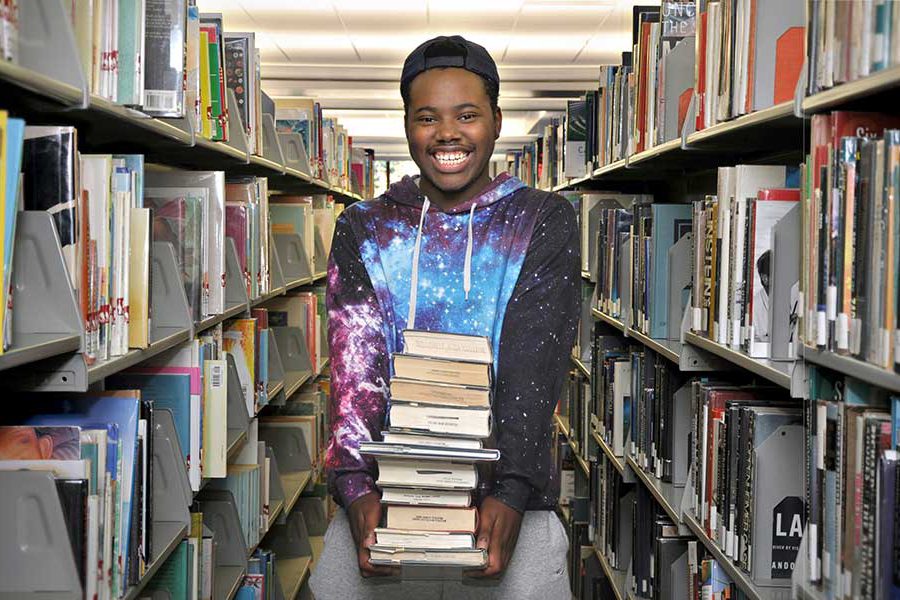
[552,66,900,192]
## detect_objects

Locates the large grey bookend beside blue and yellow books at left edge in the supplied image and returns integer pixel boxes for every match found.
[0,211,84,369]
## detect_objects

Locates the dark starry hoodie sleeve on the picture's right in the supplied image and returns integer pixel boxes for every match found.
[492,196,580,512]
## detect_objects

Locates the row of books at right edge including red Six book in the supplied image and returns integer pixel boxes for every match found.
[800,111,900,371]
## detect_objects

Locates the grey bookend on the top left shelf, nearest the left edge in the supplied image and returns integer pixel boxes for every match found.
[18,0,90,109]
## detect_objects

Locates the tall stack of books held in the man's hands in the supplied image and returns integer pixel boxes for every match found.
[360,330,500,568]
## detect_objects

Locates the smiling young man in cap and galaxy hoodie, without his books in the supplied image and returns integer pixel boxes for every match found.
[310,36,580,600]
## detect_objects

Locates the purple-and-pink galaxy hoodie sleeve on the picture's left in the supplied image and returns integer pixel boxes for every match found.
[325,212,390,507]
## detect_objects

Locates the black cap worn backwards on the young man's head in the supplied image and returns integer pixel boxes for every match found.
[400,35,500,89]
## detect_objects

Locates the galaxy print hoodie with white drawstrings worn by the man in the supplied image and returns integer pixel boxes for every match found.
[326,174,580,511]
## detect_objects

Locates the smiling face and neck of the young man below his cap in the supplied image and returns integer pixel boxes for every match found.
[406,68,502,209]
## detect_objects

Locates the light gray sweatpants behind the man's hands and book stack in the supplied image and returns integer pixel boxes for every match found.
[309,510,572,600]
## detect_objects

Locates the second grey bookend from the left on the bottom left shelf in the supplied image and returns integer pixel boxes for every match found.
[144,408,193,568]
